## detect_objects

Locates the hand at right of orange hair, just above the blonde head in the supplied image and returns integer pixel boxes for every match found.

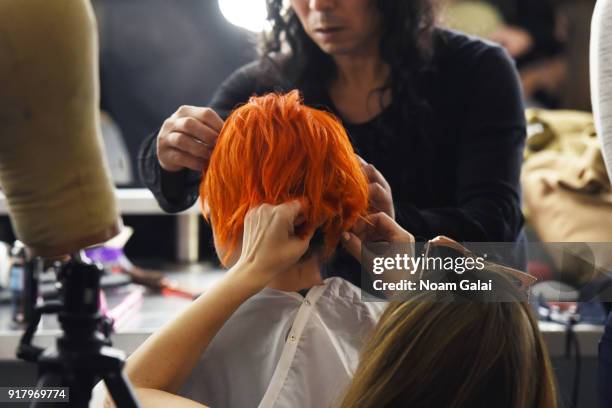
[342,212,414,261]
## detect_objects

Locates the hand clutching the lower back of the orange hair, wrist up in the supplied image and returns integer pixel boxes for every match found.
[237,201,314,288]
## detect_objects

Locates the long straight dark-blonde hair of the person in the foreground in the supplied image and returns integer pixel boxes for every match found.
[341,272,556,408]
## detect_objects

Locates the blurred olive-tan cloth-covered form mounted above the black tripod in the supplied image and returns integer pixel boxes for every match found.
[0,0,120,256]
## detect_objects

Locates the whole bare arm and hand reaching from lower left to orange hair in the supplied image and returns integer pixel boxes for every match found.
[104,201,311,406]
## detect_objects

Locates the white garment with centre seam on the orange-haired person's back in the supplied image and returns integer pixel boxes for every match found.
[181,277,386,408]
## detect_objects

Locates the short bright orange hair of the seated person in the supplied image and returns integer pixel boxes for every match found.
[200,91,368,262]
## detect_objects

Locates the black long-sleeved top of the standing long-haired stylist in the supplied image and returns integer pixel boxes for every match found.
[139,29,525,278]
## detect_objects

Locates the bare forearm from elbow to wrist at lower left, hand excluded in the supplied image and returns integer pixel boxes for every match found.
[126,266,258,394]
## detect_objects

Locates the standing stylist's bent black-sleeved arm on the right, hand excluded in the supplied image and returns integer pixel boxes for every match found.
[395,48,526,242]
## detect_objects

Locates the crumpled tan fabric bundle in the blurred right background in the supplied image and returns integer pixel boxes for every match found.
[521,110,612,281]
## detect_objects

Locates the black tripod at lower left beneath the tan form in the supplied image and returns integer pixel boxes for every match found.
[17,255,138,408]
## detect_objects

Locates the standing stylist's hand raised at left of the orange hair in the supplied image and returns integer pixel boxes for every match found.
[157,106,223,172]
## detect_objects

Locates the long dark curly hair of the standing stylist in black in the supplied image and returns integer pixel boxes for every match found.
[260,0,436,155]
